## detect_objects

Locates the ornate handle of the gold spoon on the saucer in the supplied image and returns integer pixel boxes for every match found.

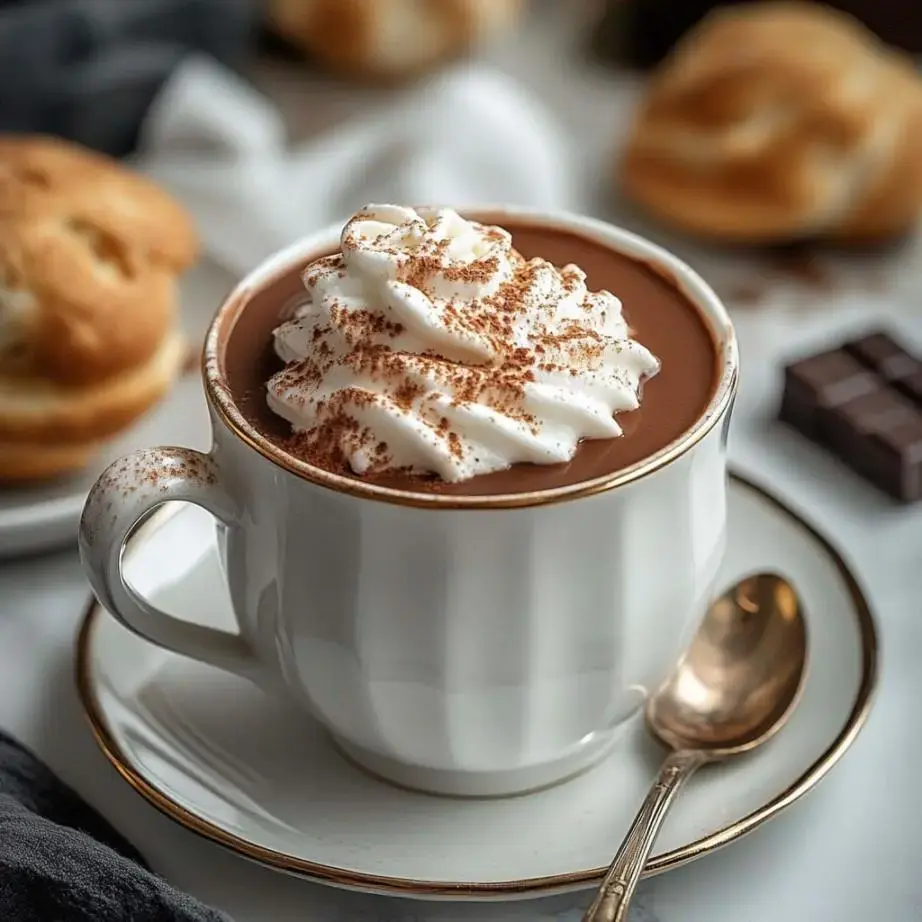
[583,750,707,922]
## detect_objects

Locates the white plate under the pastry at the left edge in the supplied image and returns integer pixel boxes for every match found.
[0,260,233,558]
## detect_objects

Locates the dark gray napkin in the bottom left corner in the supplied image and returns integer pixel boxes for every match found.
[0,728,230,922]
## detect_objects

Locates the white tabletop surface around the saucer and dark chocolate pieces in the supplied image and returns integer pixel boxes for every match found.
[0,4,922,922]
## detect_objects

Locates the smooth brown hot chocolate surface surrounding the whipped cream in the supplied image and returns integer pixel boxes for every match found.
[221,214,720,496]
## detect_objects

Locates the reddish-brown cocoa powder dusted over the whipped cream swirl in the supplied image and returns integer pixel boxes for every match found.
[266,215,652,474]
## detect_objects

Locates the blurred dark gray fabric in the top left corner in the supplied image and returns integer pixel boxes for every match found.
[0,0,256,156]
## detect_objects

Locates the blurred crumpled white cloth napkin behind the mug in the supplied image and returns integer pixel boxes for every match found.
[136,57,574,274]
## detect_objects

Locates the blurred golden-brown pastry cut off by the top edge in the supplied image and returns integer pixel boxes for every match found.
[268,0,523,78]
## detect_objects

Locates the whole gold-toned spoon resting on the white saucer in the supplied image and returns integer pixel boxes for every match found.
[583,573,807,922]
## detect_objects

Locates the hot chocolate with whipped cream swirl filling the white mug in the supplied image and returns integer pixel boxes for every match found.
[225,209,718,495]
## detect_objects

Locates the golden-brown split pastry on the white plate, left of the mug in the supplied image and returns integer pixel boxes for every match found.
[0,136,198,481]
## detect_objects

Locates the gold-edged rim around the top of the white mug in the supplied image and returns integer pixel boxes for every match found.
[202,206,739,509]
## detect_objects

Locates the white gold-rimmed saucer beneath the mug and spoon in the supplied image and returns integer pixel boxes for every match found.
[77,480,877,900]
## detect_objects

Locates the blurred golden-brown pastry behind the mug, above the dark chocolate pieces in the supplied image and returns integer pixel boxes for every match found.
[621,2,922,243]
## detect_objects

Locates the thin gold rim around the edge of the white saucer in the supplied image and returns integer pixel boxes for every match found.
[75,474,878,899]
